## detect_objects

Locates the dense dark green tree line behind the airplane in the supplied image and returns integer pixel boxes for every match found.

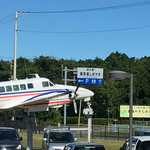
[0,52,150,122]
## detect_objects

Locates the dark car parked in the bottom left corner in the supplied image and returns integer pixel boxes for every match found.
[0,127,24,150]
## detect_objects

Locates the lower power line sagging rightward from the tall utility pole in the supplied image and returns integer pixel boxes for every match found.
[17,25,150,34]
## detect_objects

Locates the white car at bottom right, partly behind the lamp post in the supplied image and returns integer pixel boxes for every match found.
[120,136,150,150]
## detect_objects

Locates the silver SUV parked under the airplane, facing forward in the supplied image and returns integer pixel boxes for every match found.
[42,128,76,150]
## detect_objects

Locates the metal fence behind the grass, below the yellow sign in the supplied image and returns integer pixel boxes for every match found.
[69,124,150,140]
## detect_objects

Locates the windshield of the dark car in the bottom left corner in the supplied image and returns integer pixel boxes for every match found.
[0,131,19,141]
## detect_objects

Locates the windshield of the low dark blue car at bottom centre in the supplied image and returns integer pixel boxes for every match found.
[74,146,105,150]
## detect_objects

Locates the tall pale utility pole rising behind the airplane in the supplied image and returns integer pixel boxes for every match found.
[13,12,17,80]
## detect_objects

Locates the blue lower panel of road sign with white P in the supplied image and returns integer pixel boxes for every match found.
[77,78,103,85]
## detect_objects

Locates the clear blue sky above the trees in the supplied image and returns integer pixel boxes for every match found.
[0,0,150,60]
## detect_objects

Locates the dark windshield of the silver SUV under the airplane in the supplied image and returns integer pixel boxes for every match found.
[49,132,74,143]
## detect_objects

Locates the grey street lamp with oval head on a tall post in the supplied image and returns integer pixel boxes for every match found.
[109,71,133,150]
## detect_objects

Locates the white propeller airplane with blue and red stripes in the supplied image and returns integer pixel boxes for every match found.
[0,74,94,112]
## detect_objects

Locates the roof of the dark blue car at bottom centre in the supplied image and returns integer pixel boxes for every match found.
[67,142,103,146]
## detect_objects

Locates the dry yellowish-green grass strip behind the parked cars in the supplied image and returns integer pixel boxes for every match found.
[19,132,124,150]
